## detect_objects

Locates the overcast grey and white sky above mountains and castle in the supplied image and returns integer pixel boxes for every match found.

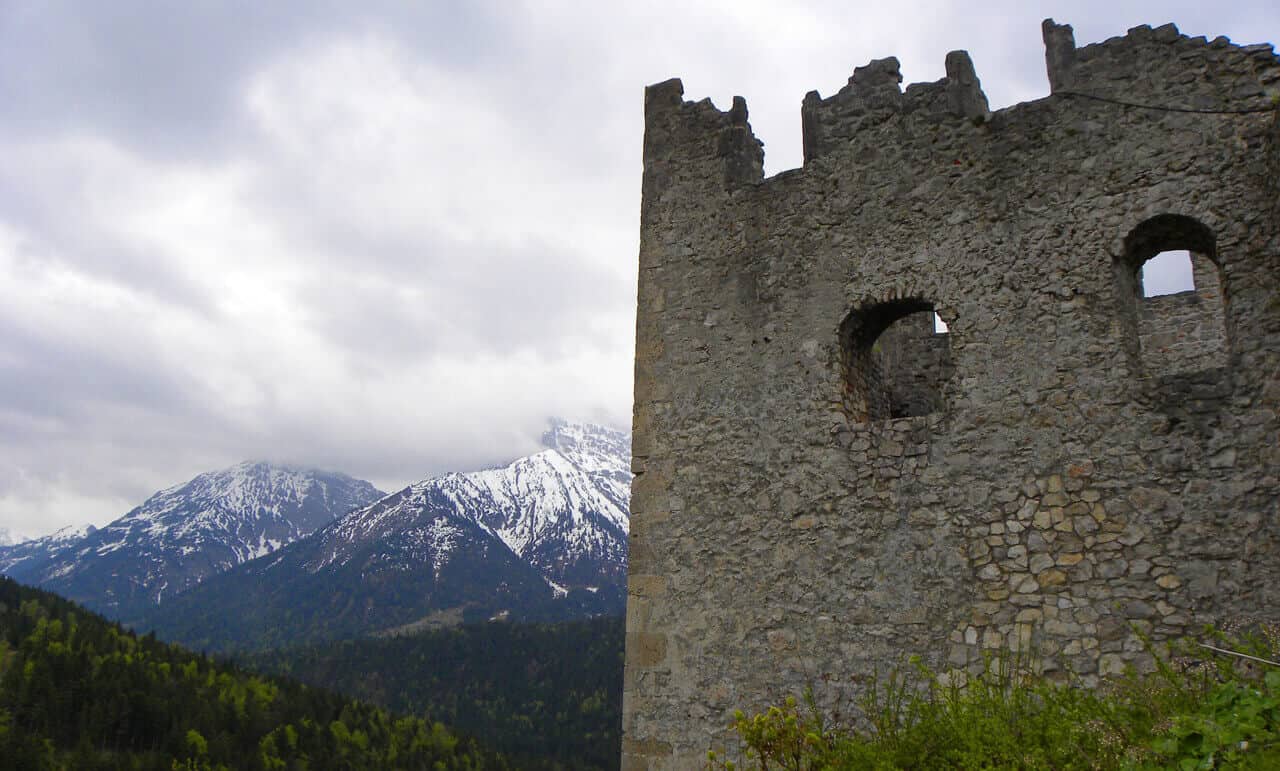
[0,0,1280,535]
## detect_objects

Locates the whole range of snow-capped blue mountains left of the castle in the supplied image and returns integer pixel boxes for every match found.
[0,420,631,649]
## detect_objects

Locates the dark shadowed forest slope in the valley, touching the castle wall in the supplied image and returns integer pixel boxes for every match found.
[244,616,623,768]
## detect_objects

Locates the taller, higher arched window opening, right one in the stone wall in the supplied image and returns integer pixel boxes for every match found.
[1119,214,1229,377]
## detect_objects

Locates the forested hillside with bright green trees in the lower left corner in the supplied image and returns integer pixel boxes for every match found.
[0,579,509,771]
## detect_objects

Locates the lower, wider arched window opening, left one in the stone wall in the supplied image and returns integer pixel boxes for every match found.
[840,298,954,423]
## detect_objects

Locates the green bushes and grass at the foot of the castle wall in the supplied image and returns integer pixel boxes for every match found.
[708,627,1280,771]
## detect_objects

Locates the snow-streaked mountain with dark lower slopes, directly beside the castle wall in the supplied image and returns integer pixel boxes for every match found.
[146,420,631,649]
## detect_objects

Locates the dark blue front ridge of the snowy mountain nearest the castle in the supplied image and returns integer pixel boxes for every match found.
[142,488,554,651]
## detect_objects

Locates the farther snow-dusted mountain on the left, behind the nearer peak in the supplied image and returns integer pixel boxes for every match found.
[4,461,383,620]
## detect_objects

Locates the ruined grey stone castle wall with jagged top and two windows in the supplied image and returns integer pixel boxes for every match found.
[623,20,1280,768]
